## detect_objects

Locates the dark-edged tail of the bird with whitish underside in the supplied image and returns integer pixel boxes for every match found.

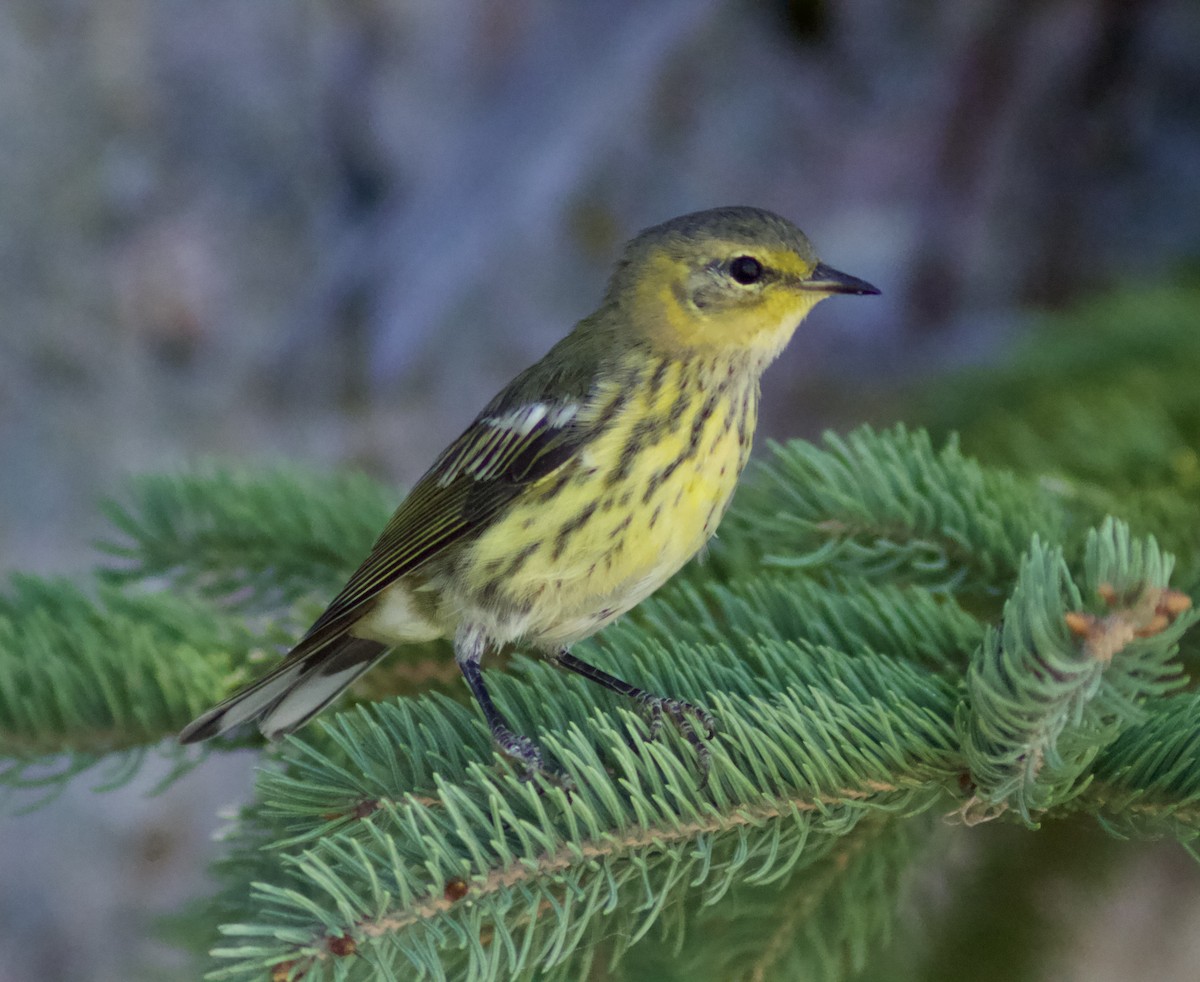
[179,634,388,743]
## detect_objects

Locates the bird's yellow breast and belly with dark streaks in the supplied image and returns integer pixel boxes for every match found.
[463,363,757,646]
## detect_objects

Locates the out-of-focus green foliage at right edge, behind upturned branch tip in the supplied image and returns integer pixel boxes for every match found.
[913,282,1200,607]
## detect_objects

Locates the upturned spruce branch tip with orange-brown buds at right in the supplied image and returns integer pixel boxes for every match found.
[958,519,1194,824]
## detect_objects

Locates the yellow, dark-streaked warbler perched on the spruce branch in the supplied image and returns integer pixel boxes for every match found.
[180,208,878,773]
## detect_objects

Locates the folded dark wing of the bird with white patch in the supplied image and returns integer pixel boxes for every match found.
[301,388,586,648]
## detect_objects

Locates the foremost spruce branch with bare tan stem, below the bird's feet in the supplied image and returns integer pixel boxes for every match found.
[201,645,955,980]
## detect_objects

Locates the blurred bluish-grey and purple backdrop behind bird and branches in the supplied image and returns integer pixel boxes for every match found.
[0,0,1200,982]
